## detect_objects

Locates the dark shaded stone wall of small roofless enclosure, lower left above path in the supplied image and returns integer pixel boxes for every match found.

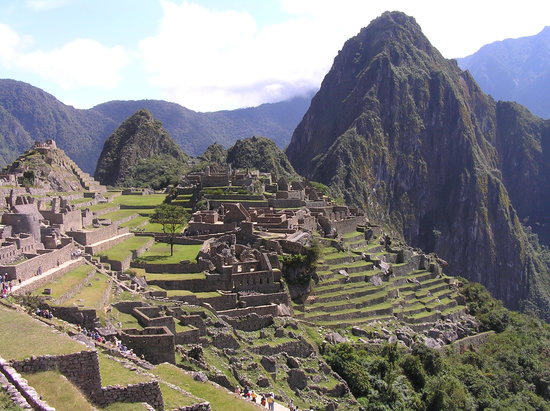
[120,327,176,364]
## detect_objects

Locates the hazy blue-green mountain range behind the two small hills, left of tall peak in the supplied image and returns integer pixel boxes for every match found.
[0,79,311,173]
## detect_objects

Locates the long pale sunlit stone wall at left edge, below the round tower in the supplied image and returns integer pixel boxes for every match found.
[0,239,76,281]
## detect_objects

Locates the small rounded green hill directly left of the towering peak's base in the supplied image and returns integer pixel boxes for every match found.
[226,137,296,178]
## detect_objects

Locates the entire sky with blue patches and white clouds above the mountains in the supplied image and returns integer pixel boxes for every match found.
[0,0,550,111]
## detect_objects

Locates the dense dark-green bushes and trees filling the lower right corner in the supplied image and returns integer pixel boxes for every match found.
[323,283,550,410]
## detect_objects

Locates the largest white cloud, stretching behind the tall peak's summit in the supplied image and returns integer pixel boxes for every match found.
[140,0,550,111]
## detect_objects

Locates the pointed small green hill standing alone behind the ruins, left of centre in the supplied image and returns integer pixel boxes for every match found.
[94,110,189,188]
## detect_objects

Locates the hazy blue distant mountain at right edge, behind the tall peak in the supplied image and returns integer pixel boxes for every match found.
[457,26,550,118]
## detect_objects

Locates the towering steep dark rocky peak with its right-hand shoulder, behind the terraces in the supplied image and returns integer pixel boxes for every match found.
[287,12,550,318]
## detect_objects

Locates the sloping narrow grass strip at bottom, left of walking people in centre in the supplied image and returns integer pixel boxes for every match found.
[151,364,258,411]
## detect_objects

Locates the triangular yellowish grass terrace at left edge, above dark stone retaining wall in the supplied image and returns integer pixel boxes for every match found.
[0,307,87,359]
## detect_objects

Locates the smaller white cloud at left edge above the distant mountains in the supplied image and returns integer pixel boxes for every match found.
[0,24,130,89]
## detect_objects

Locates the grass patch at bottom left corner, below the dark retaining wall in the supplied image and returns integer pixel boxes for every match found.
[23,371,94,411]
